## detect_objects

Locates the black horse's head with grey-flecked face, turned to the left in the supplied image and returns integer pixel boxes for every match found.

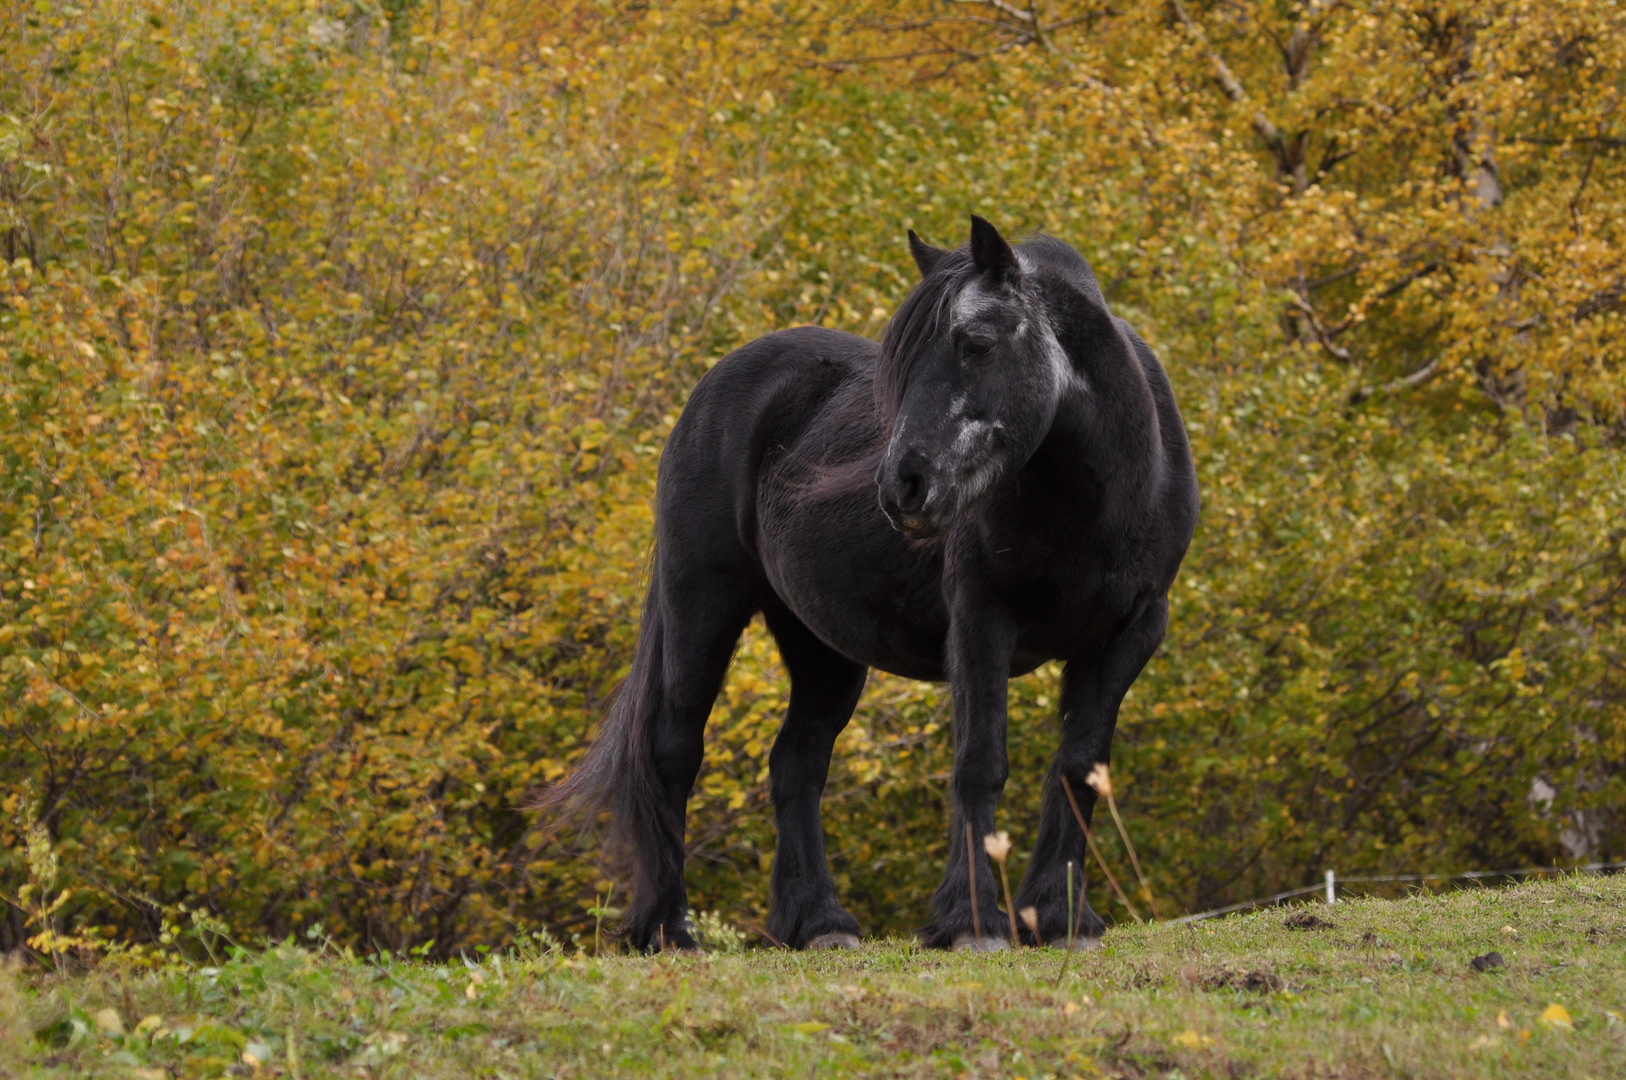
[875,216,1093,540]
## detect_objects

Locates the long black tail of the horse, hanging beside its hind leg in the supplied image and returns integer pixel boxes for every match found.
[533,566,683,943]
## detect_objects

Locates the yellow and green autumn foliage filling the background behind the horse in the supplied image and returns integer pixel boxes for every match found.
[0,0,1626,950]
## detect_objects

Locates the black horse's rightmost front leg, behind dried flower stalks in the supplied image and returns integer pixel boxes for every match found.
[1016,597,1169,947]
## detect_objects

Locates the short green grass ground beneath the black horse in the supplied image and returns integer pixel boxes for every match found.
[12,877,1626,1080]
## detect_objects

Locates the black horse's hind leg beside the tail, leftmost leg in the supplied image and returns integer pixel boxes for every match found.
[623,569,756,950]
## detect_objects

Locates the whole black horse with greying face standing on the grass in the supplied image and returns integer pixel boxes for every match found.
[543,216,1197,950]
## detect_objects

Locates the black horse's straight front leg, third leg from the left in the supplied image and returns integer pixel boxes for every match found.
[920,603,1016,948]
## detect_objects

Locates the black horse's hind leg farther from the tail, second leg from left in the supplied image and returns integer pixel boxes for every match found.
[764,607,868,948]
